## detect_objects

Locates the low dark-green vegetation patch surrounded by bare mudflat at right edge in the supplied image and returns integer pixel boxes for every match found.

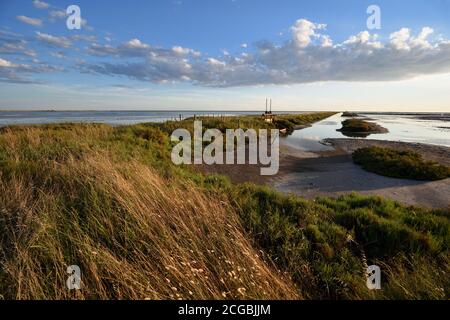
[353,147,450,180]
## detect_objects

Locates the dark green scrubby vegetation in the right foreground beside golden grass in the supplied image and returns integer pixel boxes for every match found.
[233,185,450,299]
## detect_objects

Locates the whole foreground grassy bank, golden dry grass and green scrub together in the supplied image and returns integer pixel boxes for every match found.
[0,115,450,299]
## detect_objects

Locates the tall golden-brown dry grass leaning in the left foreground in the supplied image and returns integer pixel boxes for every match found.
[0,153,299,299]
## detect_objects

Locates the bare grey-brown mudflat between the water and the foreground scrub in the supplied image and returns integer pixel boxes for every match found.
[194,139,450,208]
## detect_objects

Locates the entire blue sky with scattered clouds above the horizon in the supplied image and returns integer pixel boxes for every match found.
[0,0,450,112]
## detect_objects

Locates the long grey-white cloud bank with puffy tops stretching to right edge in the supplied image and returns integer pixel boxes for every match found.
[83,19,450,87]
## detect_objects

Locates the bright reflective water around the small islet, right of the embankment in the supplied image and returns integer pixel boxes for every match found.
[285,113,450,151]
